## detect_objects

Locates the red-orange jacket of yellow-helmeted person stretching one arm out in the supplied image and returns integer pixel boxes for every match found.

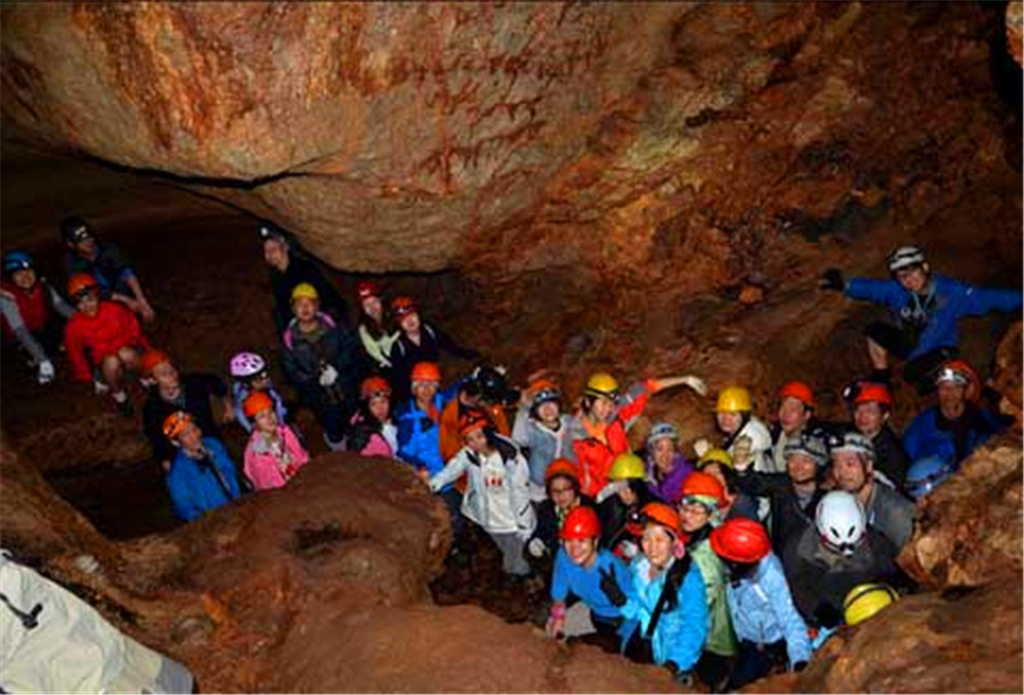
[572,383,651,497]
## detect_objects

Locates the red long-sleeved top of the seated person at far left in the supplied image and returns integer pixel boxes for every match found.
[65,301,150,382]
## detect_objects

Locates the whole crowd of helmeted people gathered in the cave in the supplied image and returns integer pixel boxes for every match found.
[0,218,1021,692]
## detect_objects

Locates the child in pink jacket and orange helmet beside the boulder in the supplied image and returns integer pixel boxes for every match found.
[243,391,309,490]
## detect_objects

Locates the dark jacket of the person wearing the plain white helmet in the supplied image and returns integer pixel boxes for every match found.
[782,525,899,627]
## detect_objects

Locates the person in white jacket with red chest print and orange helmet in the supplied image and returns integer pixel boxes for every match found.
[427,410,537,577]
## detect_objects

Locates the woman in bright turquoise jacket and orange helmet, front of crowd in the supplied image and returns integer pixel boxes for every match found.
[602,502,710,686]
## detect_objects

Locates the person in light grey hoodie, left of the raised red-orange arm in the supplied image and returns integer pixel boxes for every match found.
[512,380,575,511]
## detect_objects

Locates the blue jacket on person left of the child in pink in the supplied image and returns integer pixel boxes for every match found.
[167,437,241,521]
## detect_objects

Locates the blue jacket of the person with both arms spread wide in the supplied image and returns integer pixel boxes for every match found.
[846,275,1021,359]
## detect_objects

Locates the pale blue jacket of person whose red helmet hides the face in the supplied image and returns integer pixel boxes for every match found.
[725,553,811,666]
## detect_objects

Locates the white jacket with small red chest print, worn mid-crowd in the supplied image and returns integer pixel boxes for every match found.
[430,434,537,540]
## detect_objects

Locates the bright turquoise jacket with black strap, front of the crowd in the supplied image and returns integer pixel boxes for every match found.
[622,555,711,670]
